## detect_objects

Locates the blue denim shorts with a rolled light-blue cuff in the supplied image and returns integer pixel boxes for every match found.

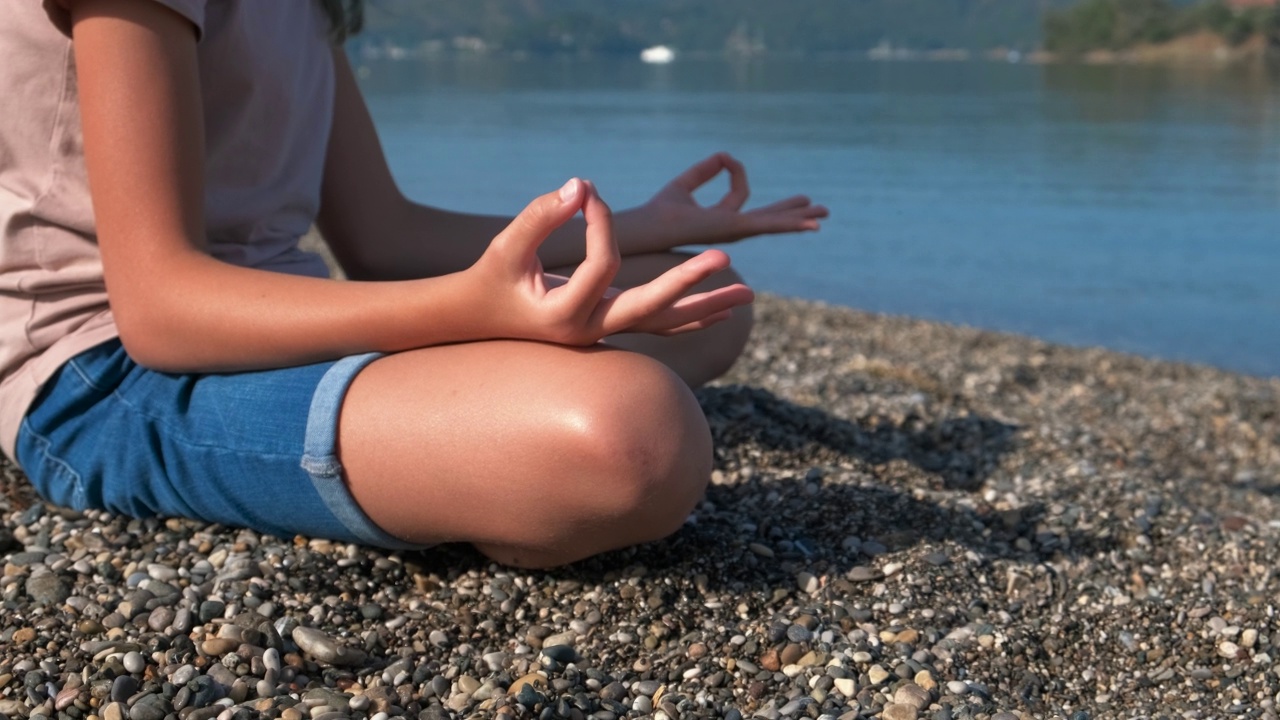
[17,340,422,550]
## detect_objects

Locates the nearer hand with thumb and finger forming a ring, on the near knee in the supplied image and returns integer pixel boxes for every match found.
[465,178,754,346]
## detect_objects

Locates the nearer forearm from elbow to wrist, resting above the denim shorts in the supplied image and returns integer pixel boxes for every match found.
[108,245,484,372]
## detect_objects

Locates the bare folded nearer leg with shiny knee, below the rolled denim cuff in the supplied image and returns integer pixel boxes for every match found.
[339,341,712,566]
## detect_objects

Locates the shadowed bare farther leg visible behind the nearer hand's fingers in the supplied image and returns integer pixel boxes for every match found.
[550,252,753,387]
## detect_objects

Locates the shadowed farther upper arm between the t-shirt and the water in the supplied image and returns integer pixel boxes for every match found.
[317,47,410,277]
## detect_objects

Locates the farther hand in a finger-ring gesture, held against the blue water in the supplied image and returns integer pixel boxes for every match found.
[618,152,827,255]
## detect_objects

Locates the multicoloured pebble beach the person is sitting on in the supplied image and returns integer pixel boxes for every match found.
[0,297,1280,720]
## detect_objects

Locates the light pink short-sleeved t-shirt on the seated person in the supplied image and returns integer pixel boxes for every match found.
[0,0,333,457]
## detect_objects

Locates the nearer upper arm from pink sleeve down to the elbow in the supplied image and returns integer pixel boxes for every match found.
[70,0,205,324]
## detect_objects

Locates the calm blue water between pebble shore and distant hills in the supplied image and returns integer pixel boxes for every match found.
[361,59,1280,375]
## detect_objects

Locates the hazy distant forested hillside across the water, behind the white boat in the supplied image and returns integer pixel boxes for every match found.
[358,0,1070,54]
